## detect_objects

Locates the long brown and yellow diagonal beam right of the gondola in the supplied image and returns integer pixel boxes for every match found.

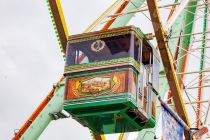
[147,0,191,140]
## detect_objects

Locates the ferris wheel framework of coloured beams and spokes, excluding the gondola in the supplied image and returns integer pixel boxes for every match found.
[13,0,210,140]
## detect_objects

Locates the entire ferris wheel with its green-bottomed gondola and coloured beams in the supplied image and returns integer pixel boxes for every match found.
[13,0,210,140]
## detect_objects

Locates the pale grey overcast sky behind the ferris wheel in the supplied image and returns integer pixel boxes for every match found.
[0,0,205,140]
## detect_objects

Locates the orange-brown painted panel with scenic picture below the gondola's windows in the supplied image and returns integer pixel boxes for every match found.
[65,69,136,100]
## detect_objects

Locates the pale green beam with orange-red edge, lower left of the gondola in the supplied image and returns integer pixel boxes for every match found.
[13,78,64,140]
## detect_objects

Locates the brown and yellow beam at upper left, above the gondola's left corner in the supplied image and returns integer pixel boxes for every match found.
[47,0,69,54]
